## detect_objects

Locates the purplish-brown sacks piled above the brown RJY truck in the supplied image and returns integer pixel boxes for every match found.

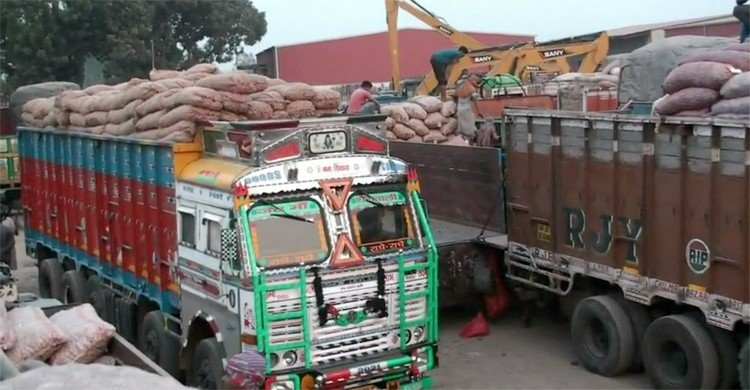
[654,45,750,116]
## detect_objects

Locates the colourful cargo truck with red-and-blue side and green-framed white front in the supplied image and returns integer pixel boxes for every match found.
[19,116,438,389]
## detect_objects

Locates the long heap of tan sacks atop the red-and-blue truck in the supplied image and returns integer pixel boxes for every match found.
[22,64,341,142]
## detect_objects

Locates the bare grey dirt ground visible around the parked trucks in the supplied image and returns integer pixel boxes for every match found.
[14,233,651,389]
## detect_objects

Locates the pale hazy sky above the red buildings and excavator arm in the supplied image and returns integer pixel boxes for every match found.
[246,0,735,54]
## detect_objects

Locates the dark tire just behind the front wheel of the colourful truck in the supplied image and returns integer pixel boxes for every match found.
[138,310,180,377]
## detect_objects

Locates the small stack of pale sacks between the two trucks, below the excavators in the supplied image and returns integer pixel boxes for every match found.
[381,96,458,143]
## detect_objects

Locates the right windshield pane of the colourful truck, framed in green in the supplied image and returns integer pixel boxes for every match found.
[348,190,415,255]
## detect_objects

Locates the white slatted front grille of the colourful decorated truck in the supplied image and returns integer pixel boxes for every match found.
[267,269,427,366]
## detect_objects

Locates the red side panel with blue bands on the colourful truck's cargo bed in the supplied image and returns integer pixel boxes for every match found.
[19,128,200,313]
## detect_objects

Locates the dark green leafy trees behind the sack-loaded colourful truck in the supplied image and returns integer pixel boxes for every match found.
[0,0,266,87]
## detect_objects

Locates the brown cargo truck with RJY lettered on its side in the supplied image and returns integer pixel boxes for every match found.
[391,107,750,389]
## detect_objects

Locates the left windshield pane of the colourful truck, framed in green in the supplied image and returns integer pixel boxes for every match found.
[247,198,330,268]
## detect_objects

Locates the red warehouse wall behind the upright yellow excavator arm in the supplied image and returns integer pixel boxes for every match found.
[277,29,534,85]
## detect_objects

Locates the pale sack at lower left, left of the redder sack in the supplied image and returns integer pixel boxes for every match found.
[8,306,64,363]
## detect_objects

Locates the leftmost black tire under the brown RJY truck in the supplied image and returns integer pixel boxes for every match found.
[571,295,635,376]
